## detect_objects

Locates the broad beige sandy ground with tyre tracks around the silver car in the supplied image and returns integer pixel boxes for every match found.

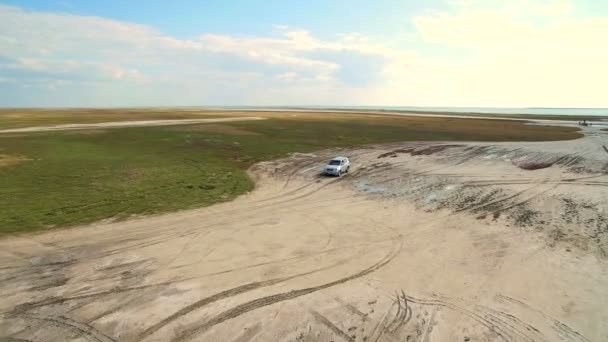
[0,128,608,342]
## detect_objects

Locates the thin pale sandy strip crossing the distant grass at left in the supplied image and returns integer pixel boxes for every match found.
[0,116,264,133]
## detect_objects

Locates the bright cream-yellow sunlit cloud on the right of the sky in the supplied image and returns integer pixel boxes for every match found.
[404,1,608,107]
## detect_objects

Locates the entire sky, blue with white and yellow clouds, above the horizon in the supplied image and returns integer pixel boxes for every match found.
[0,0,608,108]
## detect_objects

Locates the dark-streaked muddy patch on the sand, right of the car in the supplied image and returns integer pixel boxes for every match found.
[353,144,608,256]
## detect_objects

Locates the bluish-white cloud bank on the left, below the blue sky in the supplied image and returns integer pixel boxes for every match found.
[0,5,422,105]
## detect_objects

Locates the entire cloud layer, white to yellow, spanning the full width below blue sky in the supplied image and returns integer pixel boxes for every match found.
[0,0,608,107]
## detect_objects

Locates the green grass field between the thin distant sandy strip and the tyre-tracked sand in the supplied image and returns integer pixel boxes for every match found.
[0,113,580,234]
